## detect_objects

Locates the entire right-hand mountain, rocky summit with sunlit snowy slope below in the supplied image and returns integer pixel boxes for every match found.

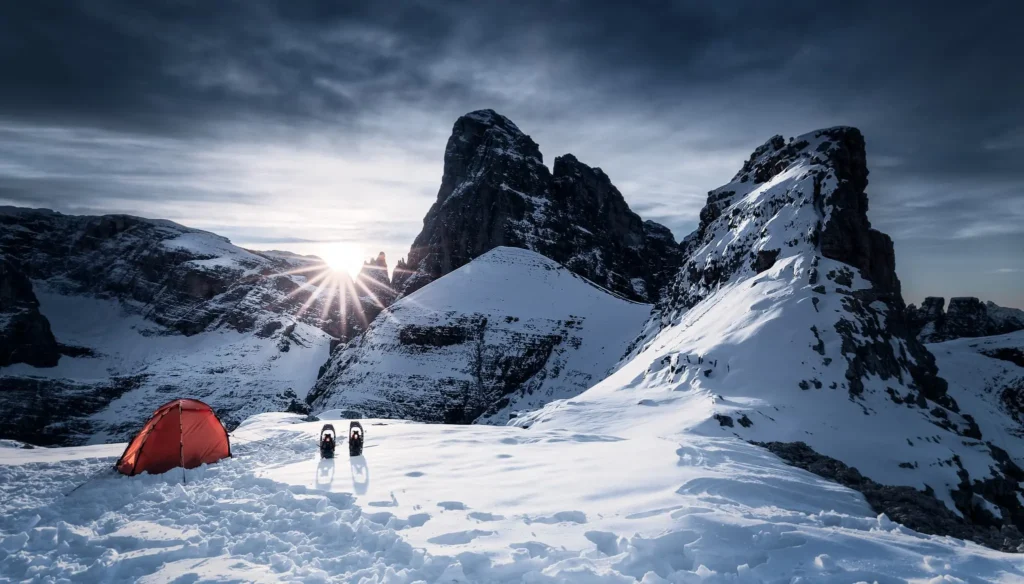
[514,128,1024,549]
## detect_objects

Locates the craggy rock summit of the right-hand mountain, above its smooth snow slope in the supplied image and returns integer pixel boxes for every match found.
[663,127,955,408]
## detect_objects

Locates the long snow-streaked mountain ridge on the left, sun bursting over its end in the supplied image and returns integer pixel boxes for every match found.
[0,207,386,444]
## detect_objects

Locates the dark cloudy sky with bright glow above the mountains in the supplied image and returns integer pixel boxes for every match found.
[0,0,1024,306]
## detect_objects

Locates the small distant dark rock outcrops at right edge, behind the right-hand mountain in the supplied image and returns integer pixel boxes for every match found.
[907,296,1024,342]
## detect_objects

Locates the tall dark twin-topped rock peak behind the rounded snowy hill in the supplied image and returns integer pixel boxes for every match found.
[394,110,682,302]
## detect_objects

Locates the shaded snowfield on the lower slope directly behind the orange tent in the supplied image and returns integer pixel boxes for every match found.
[0,287,331,445]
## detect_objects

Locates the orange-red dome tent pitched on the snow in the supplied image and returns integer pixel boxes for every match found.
[116,400,231,476]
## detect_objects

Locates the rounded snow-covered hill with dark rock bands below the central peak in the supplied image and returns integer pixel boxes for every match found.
[310,247,651,423]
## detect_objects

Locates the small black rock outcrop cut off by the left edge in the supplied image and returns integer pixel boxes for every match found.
[0,256,60,367]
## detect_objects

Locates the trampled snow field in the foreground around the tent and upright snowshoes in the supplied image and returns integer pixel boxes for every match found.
[0,414,1024,584]
